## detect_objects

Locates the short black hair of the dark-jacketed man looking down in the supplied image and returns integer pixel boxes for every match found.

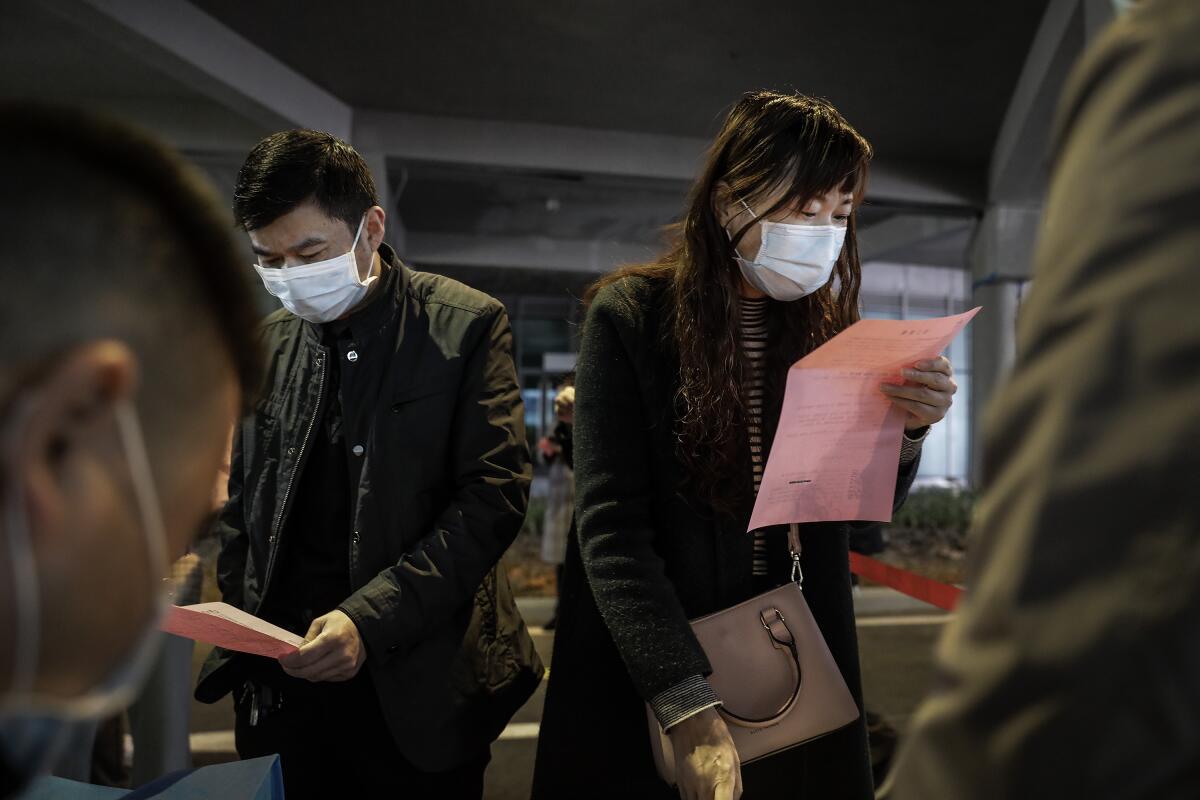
[233,131,379,230]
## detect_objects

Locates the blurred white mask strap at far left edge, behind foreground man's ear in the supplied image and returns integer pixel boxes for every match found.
[4,397,42,697]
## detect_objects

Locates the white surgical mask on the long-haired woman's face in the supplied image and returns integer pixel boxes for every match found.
[725,200,846,302]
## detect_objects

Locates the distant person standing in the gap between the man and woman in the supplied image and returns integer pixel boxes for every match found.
[539,375,575,631]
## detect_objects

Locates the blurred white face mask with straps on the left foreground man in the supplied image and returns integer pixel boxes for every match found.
[0,401,168,729]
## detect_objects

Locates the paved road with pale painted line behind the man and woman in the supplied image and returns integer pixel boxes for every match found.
[180,588,947,800]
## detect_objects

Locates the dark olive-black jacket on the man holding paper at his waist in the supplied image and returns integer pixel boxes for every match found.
[196,247,542,771]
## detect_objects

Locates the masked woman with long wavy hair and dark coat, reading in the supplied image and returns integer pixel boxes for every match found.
[534,91,955,800]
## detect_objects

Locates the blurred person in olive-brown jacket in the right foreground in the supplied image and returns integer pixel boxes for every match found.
[888,0,1200,800]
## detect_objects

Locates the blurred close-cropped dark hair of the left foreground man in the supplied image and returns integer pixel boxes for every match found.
[0,103,262,443]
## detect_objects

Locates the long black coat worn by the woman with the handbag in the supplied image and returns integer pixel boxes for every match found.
[534,278,917,800]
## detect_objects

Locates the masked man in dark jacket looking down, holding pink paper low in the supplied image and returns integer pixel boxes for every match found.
[197,131,542,798]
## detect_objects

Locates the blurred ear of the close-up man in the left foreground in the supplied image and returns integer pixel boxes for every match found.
[5,341,138,540]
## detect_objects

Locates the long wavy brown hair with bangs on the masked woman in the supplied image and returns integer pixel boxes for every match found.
[588,91,871,512]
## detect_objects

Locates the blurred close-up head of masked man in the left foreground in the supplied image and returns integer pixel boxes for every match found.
[0,106,258,796]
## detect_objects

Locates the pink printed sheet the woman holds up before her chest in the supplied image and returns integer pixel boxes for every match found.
[750,308,979,530]
